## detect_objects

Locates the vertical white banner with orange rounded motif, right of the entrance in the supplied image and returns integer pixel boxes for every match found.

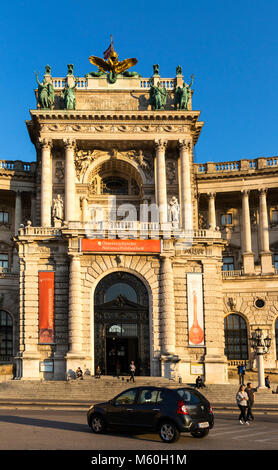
[187,273,205,347]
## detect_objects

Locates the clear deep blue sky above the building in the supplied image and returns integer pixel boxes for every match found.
[0,0,278,163]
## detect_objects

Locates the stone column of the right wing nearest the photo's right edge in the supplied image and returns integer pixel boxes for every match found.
[259,188,273,274]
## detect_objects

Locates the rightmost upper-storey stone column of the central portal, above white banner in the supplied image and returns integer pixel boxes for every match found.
[179,140,193,231]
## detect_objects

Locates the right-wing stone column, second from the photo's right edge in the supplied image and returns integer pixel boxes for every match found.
[241,189,254,274]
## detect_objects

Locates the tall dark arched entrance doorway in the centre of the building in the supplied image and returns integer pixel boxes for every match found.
[94,271,150,375]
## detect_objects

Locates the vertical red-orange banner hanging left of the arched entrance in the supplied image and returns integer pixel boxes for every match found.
[39,271,54,344]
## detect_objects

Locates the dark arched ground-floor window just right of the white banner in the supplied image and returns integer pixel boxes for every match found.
[224,313,248,360]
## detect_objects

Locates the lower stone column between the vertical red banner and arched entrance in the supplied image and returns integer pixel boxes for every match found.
[66,253,84,371]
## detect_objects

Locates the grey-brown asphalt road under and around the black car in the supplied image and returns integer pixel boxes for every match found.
[0,409,278,453]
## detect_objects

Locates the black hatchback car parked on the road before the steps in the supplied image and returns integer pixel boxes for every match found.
[87,386,214,443]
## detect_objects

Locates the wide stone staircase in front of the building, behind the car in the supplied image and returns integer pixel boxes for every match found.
[0,376,278,411]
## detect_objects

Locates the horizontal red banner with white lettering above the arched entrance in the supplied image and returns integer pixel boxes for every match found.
[80,238,161,253]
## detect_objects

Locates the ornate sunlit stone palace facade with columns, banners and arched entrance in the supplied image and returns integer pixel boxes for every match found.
[0,58,278,383]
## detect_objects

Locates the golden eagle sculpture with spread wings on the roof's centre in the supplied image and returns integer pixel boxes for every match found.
[88,42,139,83]
